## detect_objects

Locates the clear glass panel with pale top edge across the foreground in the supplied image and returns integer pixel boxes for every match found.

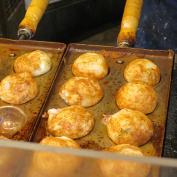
[0,140,177,177]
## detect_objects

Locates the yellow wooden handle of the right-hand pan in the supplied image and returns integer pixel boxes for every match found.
[117,0,143,47]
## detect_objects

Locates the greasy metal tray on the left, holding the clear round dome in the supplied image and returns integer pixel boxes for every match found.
[0,39,66,141]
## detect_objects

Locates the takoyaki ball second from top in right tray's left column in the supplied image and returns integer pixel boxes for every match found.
[59,77,104,107]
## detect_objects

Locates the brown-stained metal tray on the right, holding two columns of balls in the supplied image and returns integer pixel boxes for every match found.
[33,44,174,156]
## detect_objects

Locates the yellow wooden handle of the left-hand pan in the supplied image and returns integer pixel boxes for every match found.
[18,0,49,39]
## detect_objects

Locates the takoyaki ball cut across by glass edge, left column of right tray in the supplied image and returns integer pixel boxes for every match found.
[29,137,81,177]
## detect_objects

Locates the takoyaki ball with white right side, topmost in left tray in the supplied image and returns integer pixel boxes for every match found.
[14,50,52,76]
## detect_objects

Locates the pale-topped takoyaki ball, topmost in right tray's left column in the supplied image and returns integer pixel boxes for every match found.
[72,52,108,79]
